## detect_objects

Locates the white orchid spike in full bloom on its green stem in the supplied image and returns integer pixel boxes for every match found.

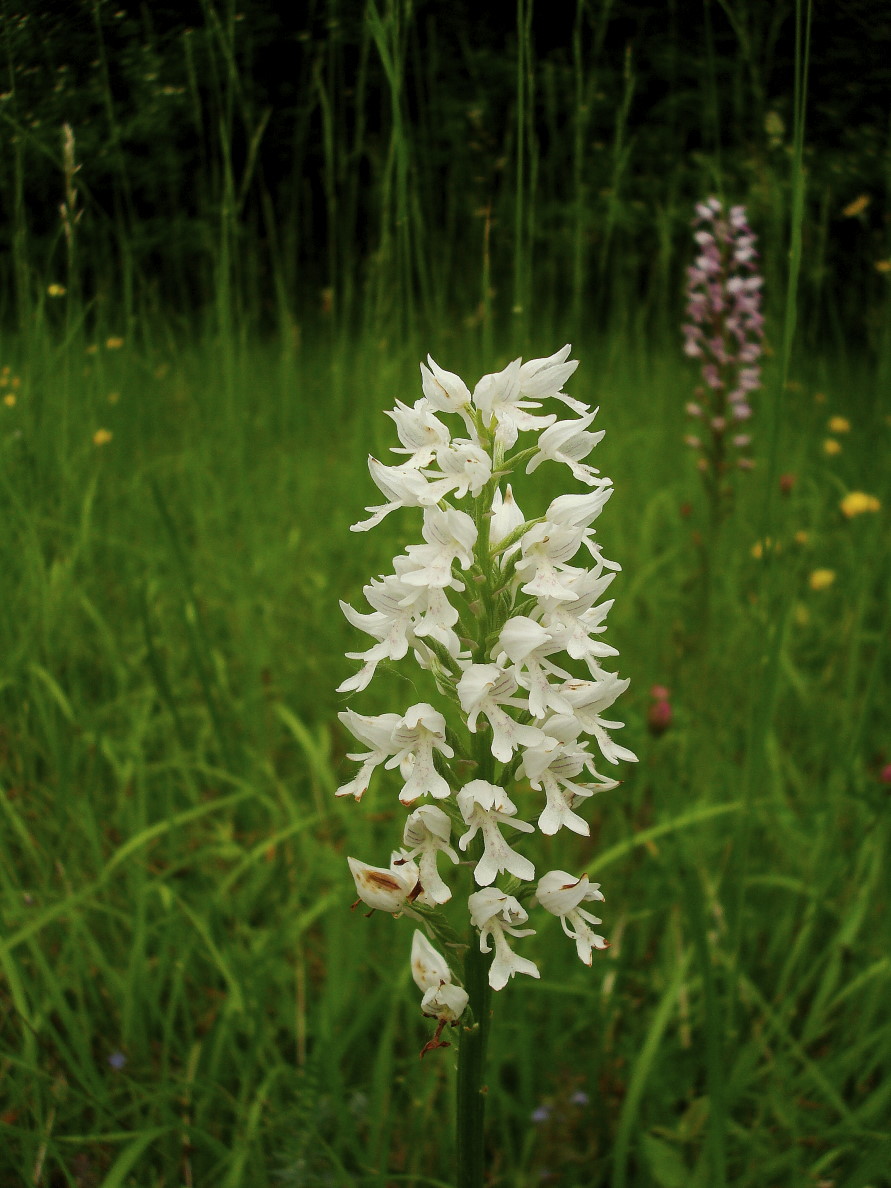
[337,346,636,1188]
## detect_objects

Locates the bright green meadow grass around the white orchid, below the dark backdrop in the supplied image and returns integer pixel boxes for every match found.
[0,318,891,1188]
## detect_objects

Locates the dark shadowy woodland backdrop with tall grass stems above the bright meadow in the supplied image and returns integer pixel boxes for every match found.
[0,0,891,340]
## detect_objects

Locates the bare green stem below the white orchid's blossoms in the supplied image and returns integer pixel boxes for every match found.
[455,928,492,1188]
